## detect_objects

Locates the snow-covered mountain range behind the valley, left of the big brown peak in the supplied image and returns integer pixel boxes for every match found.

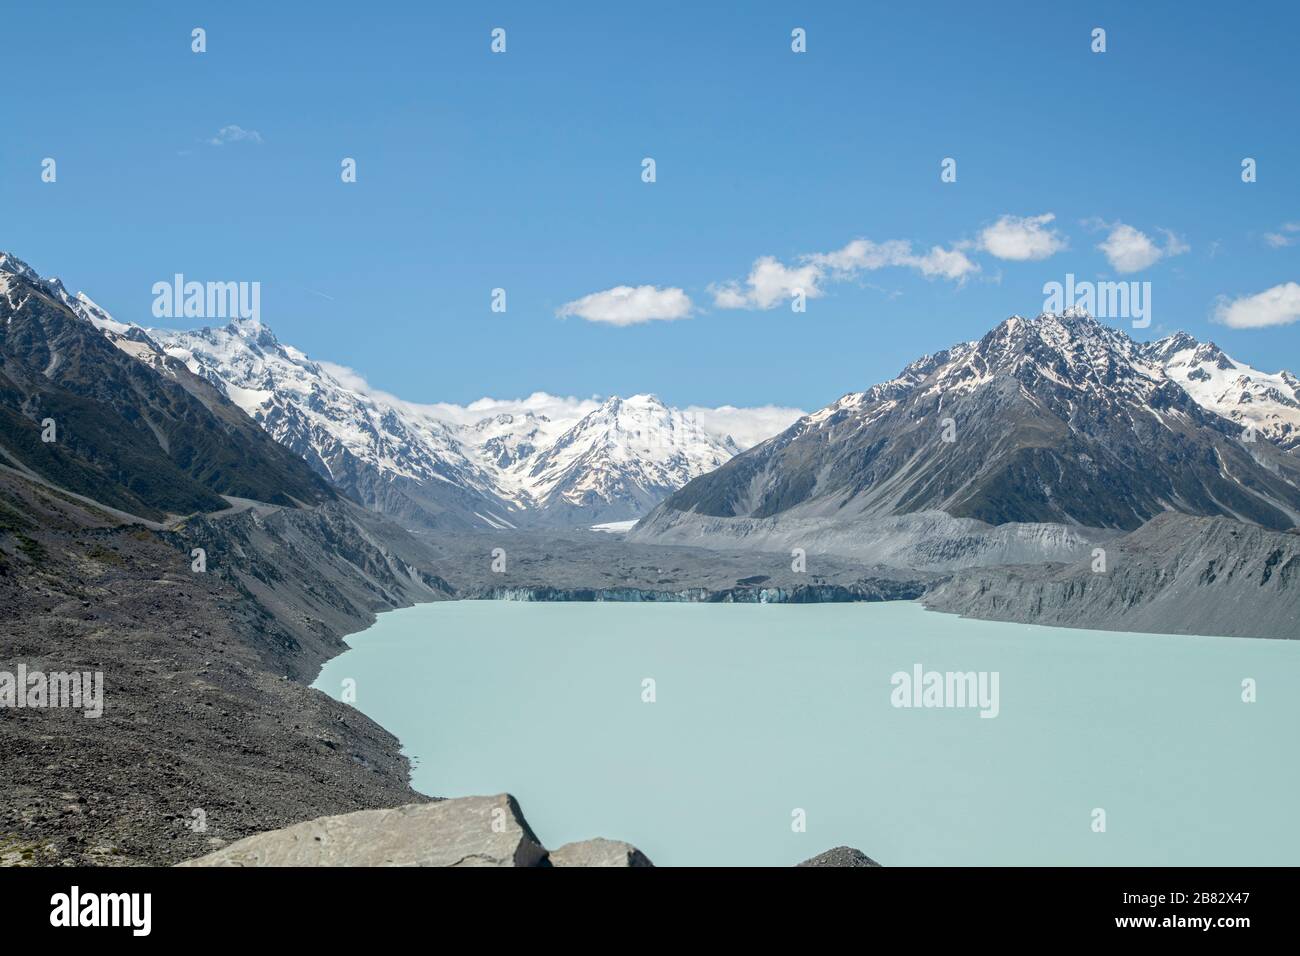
[0,252,754,528]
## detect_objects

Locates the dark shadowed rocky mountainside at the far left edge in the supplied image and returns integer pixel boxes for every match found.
[0,256,337,519]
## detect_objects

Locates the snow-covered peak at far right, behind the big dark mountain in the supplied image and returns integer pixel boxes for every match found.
[1143,332,1300,450]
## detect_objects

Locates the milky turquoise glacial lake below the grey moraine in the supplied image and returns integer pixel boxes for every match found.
[316,601,1300,866]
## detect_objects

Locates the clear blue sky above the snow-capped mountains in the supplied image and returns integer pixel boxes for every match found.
[0,0,1300,408]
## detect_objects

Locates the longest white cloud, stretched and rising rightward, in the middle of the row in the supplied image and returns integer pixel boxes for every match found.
[710,239,979,308]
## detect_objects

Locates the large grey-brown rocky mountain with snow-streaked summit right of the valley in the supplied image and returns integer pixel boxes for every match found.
[655,313,1300,531]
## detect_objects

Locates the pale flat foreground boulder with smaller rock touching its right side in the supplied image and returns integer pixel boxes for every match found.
[181,793,653,866]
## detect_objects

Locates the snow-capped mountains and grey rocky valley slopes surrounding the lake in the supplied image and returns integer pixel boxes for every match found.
[0,248,1300,864]
